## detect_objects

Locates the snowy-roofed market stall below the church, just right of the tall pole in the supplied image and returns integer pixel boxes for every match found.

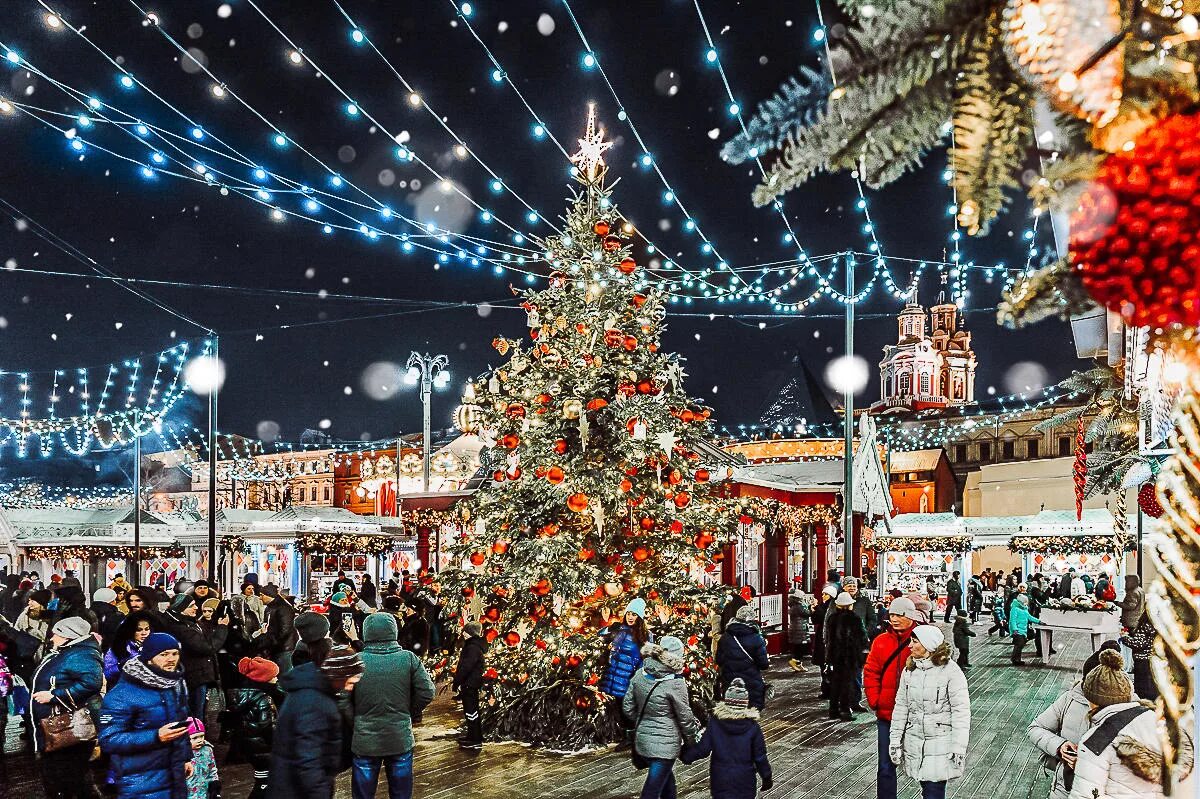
[871,513,973,609]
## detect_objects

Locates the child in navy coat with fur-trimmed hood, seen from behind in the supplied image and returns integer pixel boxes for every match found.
[696,679,773,799]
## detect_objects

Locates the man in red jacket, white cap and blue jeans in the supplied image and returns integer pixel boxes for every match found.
[863,596,924,799]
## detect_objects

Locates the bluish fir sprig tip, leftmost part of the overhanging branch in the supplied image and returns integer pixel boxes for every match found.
[721,66,833,163]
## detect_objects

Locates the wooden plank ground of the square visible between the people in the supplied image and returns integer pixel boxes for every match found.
[0,625,1088,799]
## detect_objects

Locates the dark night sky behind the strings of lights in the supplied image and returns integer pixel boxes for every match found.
[0,0,1076,467]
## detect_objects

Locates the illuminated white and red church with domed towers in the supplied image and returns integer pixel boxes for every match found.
[871,292,976,413]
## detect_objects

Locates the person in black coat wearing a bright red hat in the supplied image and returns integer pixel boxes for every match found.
[221,657,283,799]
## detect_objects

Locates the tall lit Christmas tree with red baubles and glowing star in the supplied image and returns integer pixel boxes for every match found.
[442,109,737,750]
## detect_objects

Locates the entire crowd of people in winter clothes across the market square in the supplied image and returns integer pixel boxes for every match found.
[0,563,1180,799]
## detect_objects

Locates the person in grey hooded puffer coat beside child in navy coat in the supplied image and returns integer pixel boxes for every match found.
[620,638,700,799]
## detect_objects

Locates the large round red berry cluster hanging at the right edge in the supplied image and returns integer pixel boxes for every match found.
[1070,114,1200,326]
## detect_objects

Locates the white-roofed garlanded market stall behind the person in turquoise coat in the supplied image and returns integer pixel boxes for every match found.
[1008,507,1134,585]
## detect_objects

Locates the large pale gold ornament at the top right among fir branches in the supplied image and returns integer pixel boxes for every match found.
[1004,0,1124,127]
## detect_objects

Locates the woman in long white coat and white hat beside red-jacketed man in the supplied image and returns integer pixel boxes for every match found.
[889,625,971,799]
